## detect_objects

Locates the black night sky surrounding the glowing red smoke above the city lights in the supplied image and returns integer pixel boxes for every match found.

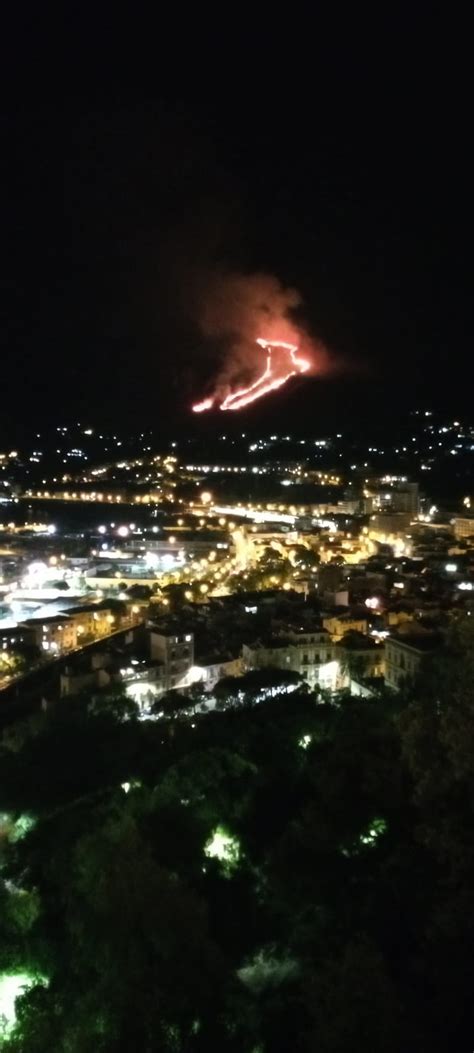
[0,16,473,431]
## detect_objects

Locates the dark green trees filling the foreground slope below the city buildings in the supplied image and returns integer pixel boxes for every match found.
[0,628,474,1053]
